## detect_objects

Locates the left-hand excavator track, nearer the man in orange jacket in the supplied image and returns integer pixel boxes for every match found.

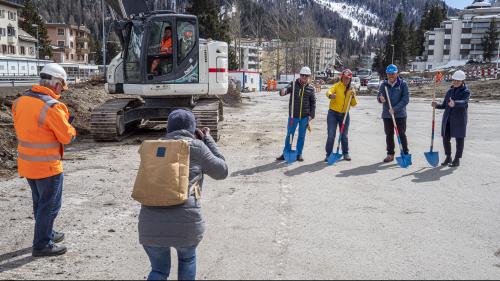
[90,98,142,141]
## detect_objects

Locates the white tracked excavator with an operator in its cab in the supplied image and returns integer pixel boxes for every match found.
[90,0,229,141]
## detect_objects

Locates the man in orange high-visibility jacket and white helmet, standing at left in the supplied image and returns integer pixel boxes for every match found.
[12,63,76,257]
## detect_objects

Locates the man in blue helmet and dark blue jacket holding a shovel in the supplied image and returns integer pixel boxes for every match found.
[377,64,410,163]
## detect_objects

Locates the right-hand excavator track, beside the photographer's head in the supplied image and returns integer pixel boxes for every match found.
[193,99,222,141]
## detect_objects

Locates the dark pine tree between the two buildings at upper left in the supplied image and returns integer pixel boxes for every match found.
[19,0,52,59]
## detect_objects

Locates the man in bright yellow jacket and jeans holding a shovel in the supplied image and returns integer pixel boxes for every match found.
[325,69,358,162]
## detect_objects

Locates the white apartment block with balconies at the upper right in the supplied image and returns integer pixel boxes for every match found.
[420,1,500,70]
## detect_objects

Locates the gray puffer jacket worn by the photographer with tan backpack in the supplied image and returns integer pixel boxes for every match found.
[139,130,228,247]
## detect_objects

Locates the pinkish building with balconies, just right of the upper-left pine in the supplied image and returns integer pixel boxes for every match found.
[47,23,90,64]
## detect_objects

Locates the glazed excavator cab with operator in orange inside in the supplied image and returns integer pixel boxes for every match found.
[120,11,200,85]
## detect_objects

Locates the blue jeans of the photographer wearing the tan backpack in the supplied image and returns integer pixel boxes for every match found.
[144,245,198,280]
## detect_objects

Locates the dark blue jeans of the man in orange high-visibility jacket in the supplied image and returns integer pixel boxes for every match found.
[28,173,64,250]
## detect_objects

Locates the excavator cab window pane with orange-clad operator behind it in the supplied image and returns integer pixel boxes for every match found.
[147,22,174,76]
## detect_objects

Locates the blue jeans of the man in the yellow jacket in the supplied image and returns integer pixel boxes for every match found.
[325,109,351,157]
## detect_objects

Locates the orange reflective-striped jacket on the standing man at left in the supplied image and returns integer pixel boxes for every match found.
[12,85,76,179]
